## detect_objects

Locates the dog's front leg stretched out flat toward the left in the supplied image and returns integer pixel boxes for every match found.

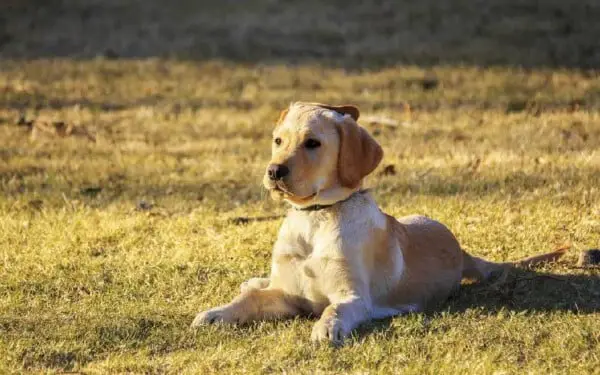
[192,289,305,327]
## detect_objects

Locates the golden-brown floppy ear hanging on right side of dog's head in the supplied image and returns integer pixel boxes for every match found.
[337,116,383,188]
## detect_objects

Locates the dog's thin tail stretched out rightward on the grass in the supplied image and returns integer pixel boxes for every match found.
[462,246,569,281]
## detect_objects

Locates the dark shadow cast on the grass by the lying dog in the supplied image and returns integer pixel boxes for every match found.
[356,267,600,337]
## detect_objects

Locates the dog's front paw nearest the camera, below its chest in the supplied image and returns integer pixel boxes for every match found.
[311,296,372,345]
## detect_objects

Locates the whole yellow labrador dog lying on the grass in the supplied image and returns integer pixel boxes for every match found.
[192,103,562,344]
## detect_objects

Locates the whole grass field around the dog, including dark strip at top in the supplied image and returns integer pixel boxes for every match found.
[0,0,600,374]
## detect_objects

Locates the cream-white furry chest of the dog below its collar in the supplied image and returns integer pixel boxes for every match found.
[271,198,379,305]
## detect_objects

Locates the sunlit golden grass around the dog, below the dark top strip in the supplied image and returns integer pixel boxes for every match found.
[0,60,600,374]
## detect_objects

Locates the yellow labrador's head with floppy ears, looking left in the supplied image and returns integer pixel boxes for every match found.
[263,102,383,207]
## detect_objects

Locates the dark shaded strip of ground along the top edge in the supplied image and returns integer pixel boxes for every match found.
[0,0,600,69]
